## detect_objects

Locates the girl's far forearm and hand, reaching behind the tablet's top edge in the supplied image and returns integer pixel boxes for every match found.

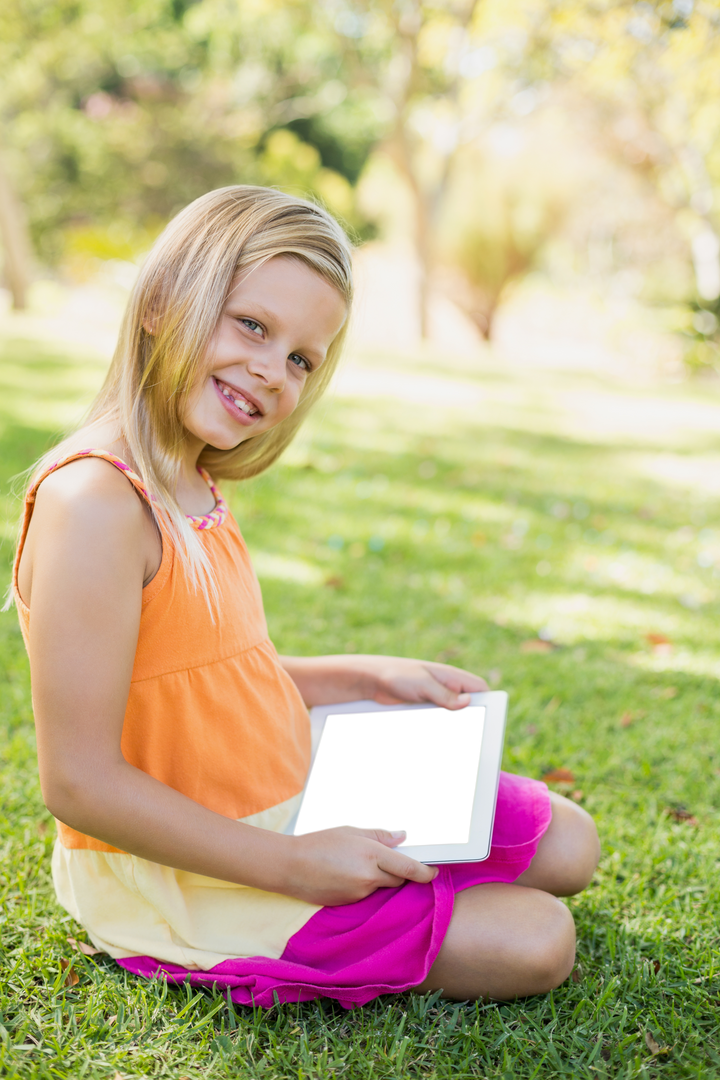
[280,656,488,710]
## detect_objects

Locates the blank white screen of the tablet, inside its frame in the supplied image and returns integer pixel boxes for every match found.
[295,707,485,845]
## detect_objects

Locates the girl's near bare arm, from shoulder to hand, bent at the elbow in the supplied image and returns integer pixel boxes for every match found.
[26,460,435,904]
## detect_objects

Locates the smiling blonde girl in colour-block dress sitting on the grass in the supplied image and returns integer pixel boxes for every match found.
[13,187,598,1008]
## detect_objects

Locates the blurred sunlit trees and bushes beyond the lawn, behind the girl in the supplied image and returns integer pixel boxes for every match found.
[0,0,720,371]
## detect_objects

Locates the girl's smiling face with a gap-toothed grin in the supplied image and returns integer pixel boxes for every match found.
[184,257,347,450]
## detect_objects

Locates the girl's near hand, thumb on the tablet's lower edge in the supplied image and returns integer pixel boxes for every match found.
[282,825,437,907]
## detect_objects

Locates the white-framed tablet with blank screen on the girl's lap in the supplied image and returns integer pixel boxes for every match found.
[291,691,507,863]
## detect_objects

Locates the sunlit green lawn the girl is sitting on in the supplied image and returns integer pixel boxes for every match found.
[0,330,720,1080]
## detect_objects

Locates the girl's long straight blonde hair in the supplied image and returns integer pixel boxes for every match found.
[33,185,353,595]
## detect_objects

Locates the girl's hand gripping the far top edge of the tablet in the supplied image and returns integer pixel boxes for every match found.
[363,657,488,711]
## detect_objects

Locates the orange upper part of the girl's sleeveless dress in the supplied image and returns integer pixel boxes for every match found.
[13,449,311,852]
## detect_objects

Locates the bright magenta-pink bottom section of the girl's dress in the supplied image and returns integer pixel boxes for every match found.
[118,772,552,1009]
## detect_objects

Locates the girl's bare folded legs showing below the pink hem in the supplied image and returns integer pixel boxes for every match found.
[417,793,600,1000]
